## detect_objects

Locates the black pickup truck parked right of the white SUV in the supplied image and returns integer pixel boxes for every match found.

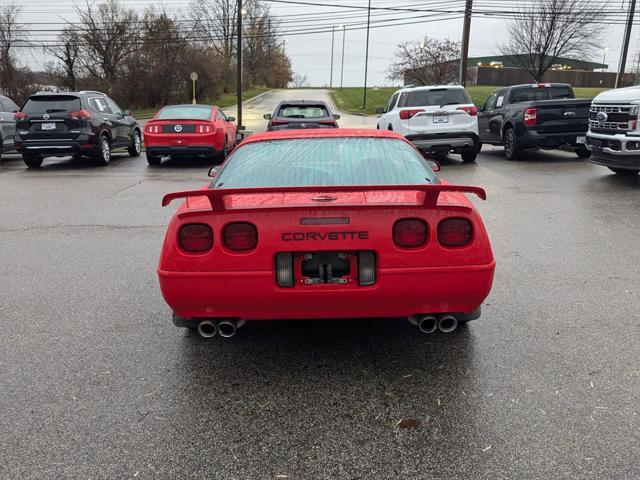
[478,83,591,160]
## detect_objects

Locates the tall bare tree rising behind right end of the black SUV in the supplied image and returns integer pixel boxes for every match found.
[75,0,140,81]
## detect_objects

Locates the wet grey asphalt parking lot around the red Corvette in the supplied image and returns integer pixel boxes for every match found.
[0,117,640,479]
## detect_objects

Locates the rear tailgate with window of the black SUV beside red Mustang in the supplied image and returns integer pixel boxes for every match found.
[17,95,82,139]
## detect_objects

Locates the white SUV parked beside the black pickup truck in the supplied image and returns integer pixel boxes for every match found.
[376,85,479,162]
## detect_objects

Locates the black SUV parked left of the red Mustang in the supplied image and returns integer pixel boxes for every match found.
[15,91,142,168]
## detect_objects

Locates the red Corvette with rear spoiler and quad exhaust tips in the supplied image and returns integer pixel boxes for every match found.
[158,129,495,337]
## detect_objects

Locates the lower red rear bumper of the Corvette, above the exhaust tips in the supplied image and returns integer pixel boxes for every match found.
[158,262,495,320]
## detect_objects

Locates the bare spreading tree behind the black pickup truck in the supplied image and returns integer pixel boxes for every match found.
[501,0,606,81]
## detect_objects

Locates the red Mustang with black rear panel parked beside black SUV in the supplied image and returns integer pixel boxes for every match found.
[144,105,236,165]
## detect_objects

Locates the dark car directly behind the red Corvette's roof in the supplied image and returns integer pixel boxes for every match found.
[263,100,340,132]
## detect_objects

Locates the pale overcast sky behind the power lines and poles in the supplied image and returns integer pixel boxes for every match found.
[8,0,640,86]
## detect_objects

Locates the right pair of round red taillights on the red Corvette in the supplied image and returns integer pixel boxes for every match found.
[393,218,473,248]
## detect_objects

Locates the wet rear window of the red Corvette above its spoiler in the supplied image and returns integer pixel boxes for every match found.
[212,137,436,188]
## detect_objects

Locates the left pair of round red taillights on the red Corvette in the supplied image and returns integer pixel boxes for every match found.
[178,222,258,253]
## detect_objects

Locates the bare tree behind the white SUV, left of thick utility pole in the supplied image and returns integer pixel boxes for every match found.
[389,36,460,85]
